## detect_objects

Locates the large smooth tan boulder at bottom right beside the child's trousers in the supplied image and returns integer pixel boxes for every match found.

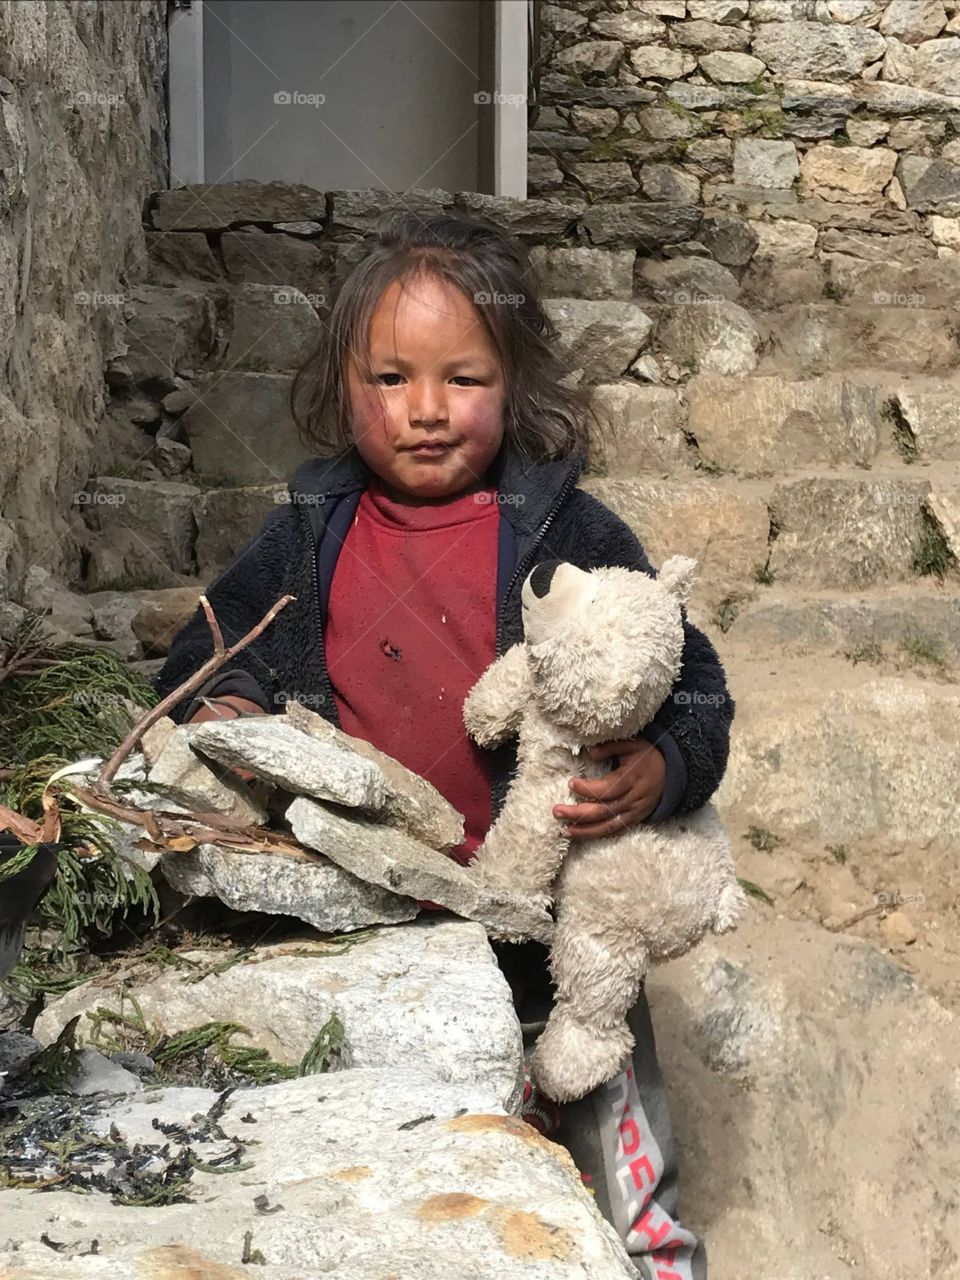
[648,916,960,1280]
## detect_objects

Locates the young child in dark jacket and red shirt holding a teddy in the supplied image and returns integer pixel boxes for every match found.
[156,214,733,1280]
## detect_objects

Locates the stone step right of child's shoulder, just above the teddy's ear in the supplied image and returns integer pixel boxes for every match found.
[582,462,960,606]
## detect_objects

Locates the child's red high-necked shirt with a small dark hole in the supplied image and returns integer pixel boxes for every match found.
[324,477,499,863]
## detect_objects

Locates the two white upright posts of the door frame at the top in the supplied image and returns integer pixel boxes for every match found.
[168,0,532,200]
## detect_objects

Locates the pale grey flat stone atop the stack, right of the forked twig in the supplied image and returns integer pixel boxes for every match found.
[191,716,385,812]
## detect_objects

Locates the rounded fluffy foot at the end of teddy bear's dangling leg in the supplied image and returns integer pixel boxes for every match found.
[531,1006,634,1102]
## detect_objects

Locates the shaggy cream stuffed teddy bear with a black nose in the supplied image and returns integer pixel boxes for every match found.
[463,556,746,1102]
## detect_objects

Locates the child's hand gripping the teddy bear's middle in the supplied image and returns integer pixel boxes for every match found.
[553,740,667,840]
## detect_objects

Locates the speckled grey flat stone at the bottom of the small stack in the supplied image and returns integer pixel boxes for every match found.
[160,845,419,933]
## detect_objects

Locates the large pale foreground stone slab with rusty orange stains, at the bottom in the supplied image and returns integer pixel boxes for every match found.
[0,1070,636,1280]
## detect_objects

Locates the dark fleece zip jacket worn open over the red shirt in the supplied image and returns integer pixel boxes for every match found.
[155,442,735,822]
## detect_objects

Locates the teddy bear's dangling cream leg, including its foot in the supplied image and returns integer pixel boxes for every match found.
[531,902,648,1102]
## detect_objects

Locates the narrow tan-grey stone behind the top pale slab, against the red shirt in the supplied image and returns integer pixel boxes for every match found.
[285,699,463,852]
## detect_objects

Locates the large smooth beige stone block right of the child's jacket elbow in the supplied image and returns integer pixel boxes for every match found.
[716,645,960,847]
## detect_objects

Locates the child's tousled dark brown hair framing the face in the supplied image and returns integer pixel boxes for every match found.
[291,211,599,462]
